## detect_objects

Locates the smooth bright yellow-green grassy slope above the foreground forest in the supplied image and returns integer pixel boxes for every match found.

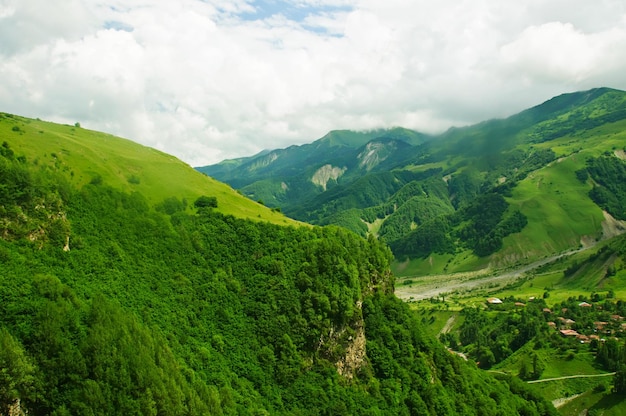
[0,114,296,224]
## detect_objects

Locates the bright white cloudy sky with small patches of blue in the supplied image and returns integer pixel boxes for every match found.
[0,0,626,166]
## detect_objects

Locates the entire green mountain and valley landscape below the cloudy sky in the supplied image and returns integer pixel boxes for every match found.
[0,88,626,416]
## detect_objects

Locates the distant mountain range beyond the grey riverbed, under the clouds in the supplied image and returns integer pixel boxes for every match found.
[197,88,626,272]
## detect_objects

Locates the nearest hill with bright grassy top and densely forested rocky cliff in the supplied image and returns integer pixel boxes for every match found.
[0,114,556,415]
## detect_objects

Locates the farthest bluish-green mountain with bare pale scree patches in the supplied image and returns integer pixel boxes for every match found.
[197,128,428,205]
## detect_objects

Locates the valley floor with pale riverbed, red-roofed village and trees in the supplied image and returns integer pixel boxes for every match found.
[404,231,626,415]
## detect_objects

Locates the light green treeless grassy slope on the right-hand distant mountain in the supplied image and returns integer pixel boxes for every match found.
[393,115,626,276]
